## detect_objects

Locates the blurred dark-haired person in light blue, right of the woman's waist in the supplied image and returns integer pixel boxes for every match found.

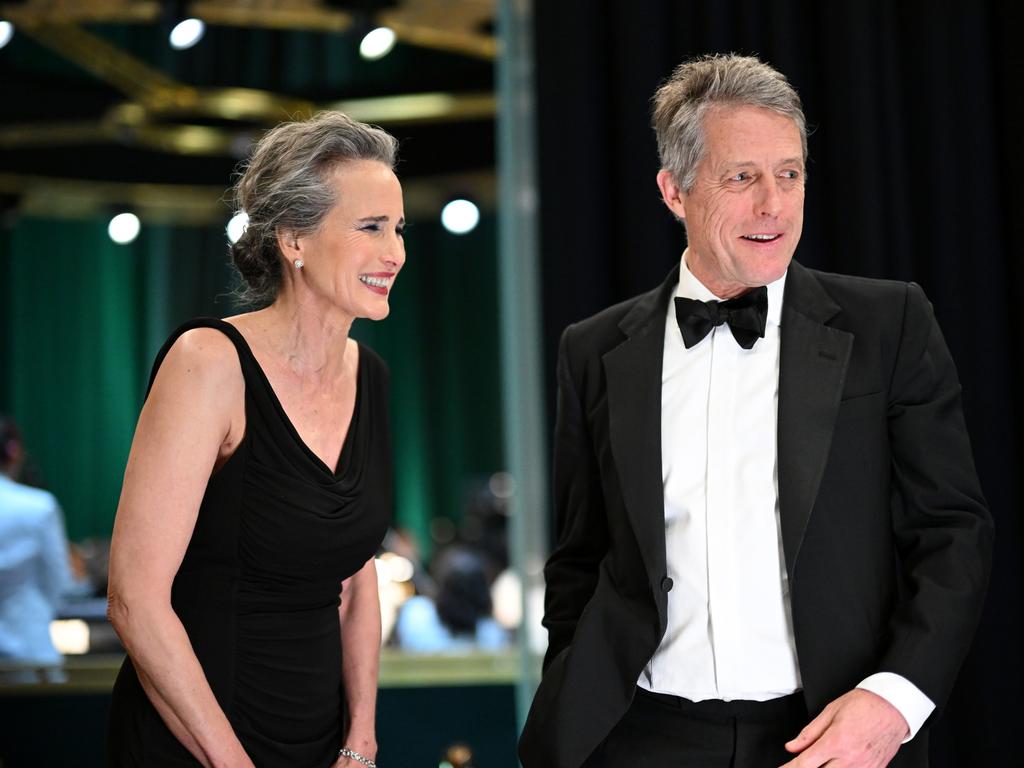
[395,545,509,653]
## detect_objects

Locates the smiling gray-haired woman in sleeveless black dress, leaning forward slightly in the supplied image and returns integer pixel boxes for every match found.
[109,112,406,768]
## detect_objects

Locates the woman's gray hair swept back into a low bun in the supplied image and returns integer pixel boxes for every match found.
[231,111,398,304]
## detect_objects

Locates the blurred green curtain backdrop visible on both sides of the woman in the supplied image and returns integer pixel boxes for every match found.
[0,215,503,556]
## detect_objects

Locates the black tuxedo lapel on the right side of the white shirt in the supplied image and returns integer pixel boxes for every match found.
[778,262,853,584]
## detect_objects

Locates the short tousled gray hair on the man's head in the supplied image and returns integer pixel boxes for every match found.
[651,53,807,193]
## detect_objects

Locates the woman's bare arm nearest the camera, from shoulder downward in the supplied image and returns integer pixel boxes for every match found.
[108,329,253,768]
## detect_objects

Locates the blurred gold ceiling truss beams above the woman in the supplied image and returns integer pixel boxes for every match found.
[0,0,498,217]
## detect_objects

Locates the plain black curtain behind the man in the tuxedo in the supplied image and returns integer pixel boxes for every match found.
[535,0,1024,768]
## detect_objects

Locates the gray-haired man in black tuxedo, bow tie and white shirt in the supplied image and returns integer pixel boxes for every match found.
[519,55,991,768]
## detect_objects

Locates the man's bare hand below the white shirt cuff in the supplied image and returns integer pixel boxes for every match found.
[782,688,909,768]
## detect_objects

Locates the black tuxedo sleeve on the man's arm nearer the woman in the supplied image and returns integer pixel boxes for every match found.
[544,326,608,670]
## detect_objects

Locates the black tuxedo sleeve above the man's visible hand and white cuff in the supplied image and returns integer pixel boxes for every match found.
[880,284,992,709]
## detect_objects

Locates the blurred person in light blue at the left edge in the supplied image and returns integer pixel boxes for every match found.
[0,415,72,683]
